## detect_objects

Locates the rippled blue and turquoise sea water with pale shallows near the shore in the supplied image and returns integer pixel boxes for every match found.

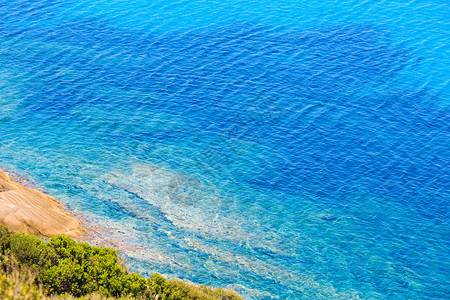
[0,0,450,299]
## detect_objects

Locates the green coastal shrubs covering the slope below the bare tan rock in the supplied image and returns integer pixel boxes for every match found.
[0,225,242,300]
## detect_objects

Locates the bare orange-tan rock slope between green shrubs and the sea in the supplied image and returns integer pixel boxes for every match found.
[0,170,85,238]
